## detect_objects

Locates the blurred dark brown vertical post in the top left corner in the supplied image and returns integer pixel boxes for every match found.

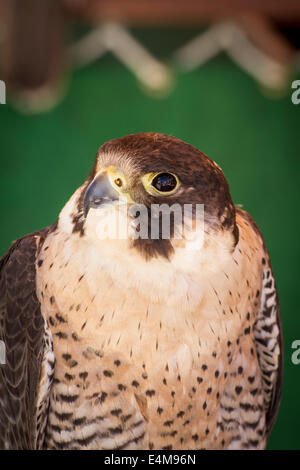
[0,0,66,97]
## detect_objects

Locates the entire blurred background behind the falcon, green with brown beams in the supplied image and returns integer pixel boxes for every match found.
[0,0,300,449]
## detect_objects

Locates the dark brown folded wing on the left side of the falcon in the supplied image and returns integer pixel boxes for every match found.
[0,228,55,449]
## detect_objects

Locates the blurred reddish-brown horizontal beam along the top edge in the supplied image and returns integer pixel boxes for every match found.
[62,0,300,26]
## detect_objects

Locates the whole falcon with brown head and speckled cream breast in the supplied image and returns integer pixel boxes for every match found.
[0,133,282,450]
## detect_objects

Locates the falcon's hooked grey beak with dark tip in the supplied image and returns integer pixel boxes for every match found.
[83,172,120,218]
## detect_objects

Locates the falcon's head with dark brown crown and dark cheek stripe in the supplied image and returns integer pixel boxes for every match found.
[60,132,238,260]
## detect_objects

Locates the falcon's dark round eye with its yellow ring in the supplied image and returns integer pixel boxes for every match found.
[142,171,180,196]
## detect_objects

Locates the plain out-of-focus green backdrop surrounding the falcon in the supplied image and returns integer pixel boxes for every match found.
[0,31,300,449]
